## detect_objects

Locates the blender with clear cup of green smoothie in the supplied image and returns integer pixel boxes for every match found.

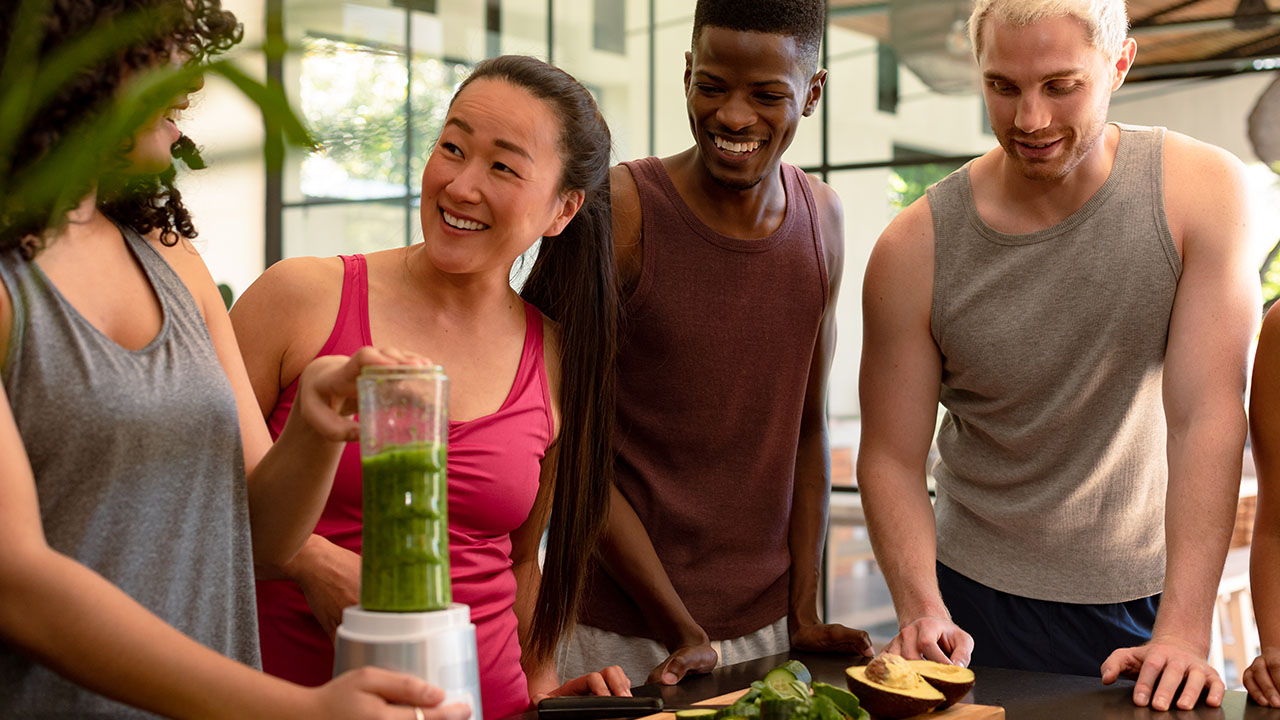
[334,365,481,717]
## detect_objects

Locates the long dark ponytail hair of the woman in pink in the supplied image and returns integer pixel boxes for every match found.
[458,55,618,660]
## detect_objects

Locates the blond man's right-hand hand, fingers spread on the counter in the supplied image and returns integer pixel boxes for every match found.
[1102,635,1226,712]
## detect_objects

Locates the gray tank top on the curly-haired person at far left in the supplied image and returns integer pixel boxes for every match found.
[0,221,260,717]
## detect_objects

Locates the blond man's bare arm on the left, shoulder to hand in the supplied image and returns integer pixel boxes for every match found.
[858,197,973,665]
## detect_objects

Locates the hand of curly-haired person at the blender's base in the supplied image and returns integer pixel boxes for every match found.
[307,667,471,720]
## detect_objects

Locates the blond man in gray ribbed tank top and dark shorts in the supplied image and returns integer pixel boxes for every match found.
[858,0,1260,710]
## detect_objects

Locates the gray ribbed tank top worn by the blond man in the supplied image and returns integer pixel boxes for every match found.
[928,126,1181,603]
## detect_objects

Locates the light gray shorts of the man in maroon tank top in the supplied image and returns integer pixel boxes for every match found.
[556,618,791,685]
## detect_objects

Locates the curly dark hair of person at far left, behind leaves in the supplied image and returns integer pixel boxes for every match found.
[0,0,243,258]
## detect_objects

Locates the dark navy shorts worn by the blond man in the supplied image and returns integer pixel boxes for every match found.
[938,562,1160,676]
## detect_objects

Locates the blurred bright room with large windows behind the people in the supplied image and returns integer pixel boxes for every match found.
[180,0,1280,683]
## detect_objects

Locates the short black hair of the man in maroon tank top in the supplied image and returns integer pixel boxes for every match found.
[694,0,827,70]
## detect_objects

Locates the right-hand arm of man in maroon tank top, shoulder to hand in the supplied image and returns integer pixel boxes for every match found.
[787,178,872,655]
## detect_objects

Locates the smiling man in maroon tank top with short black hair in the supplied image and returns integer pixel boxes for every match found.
[561,0,869,683]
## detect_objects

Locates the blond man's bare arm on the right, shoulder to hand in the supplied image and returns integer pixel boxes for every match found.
[1103,133,1261,710]
